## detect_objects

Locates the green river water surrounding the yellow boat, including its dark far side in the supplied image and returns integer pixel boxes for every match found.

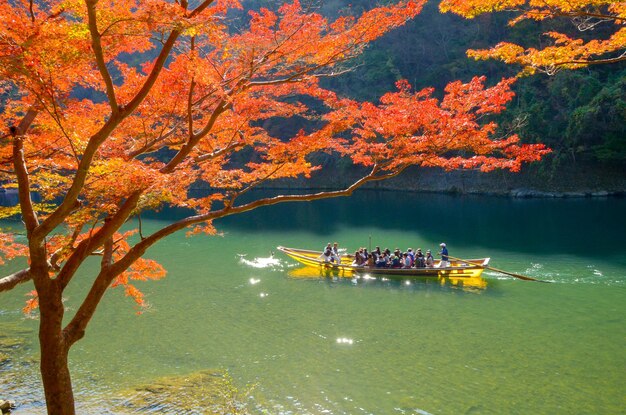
[0,191,626,415]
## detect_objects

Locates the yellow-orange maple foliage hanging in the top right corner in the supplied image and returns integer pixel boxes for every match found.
[440,0,626,75]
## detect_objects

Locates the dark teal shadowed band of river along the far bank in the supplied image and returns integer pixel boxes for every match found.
[212,191,626,261]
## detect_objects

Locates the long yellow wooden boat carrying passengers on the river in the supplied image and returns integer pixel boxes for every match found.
[276,246,490,279]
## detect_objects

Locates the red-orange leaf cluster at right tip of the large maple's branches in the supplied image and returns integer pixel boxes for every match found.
[324,78,549,171]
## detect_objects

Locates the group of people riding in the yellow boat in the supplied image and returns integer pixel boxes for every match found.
[320,242,450,268]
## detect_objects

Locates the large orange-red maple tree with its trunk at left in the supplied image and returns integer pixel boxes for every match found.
[0,0,549,415]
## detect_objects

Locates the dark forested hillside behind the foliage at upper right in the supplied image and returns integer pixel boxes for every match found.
[322,0,626,165]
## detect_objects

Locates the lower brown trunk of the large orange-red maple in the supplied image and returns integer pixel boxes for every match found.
[39,281,76,415]
